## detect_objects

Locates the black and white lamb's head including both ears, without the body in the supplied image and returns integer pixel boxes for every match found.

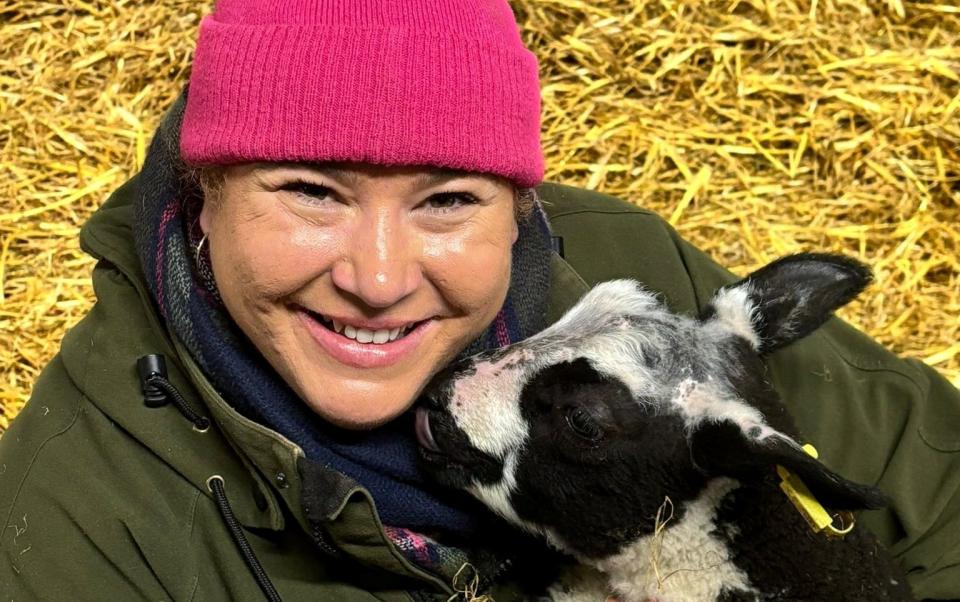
[417,254,883,558]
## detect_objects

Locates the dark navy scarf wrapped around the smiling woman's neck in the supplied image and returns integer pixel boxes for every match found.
[134,92,552,536]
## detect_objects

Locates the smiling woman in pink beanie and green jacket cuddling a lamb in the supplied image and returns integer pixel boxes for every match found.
[0,0,960,600]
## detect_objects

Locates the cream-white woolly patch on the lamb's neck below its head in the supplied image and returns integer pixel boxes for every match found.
[581,478,754,601]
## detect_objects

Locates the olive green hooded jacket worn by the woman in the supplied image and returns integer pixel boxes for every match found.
[0,170,960,602]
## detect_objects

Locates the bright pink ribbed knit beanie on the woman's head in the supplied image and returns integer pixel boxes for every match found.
[180,0,543,187]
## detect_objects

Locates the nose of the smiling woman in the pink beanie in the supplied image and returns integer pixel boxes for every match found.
[332,210,423,308]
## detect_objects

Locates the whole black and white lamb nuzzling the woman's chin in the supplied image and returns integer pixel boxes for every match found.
[417,254,910,602]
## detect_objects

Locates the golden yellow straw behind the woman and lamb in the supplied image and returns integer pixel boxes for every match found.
[0,0,960,431]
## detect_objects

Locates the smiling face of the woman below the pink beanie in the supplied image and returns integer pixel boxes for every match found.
[200,163,517,428]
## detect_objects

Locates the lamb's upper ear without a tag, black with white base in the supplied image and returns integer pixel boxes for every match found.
[705,253,872,354]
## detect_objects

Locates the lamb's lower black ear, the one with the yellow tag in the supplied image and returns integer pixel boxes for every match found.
[690,421,887,510]
